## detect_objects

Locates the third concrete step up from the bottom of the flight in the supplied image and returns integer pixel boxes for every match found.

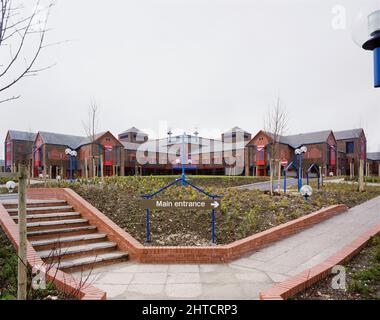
[30,233,107,251]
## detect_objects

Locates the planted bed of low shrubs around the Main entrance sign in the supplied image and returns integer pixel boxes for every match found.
[37,177,380,246]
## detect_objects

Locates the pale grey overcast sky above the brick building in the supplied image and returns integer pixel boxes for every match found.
[0,0,380,158]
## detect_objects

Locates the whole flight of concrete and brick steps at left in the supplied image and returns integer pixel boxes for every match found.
[3,200,128,272]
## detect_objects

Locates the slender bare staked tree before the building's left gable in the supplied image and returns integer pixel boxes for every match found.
[82,100,103,178]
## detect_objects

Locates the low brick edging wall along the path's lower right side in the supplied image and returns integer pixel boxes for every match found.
[260,224,380,300]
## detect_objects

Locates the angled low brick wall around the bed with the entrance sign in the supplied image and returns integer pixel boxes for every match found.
[27,188,347,263]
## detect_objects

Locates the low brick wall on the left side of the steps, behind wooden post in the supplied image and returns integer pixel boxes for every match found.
[0,203,106,300]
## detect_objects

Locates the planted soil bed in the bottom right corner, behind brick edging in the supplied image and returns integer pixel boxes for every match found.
[293,237,380,300]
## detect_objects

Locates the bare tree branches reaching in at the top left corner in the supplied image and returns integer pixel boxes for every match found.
[0,0,53,103]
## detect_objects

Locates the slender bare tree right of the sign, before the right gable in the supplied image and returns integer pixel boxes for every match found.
[264,96,288,195]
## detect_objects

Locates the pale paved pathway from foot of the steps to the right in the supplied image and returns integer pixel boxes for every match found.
[75,197,380,299]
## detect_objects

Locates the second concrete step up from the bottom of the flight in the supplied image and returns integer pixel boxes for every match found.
[37,241,117,262]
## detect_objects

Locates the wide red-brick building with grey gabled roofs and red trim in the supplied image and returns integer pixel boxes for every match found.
[4,127,372,178]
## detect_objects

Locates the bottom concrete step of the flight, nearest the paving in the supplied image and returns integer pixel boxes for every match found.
[60,251,128,272]
